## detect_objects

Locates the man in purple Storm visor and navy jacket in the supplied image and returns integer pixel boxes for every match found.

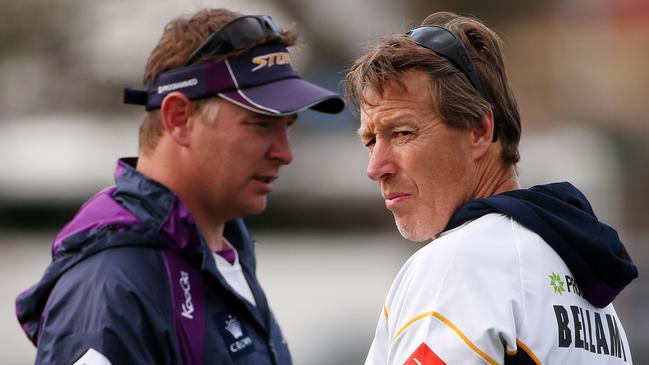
[16,9,344,365]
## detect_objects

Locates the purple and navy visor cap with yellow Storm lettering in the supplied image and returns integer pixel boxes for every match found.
[124,44,345,116]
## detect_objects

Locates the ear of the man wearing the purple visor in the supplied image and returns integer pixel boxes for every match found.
[160,91,194,146]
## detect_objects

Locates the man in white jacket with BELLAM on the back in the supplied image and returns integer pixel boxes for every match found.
[346,12,638,365]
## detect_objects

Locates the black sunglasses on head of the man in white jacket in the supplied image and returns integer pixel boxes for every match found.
[406,25,487,99]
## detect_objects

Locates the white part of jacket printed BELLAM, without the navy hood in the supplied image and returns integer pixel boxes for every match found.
[365,214,632,365]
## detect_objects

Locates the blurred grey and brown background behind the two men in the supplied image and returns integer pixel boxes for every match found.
[0,0,649,364]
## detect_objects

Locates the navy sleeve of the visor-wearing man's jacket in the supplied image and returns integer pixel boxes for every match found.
[36,247,178,365]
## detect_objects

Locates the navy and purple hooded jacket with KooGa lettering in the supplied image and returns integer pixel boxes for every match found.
[16,159,291,365]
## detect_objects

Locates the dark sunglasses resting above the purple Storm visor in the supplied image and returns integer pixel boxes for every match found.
[183,15,281,66]
